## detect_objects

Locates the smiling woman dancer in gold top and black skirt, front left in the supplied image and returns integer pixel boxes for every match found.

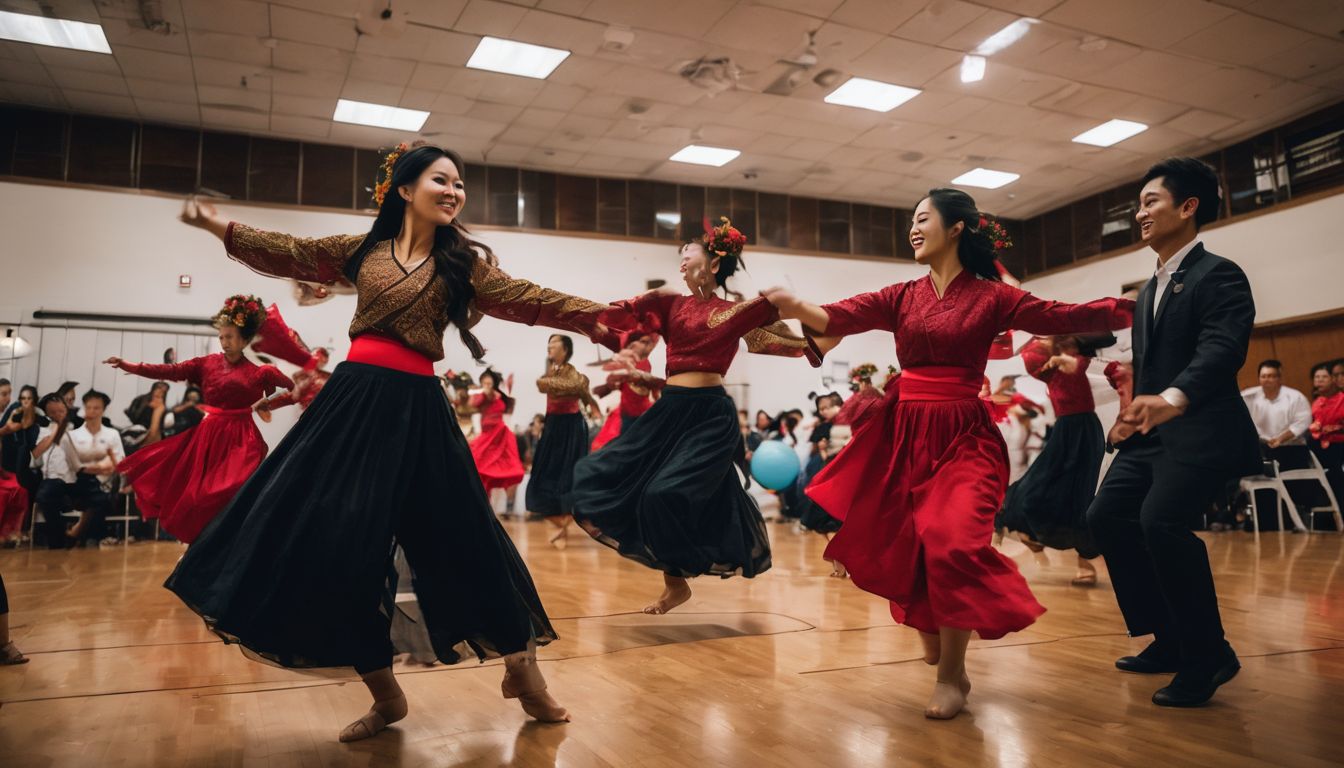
[167,147,633,741]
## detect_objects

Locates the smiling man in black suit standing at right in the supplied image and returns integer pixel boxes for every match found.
[1087,157,1261,706]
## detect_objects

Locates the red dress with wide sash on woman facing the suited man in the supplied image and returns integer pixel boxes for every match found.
[806,272,1133,639]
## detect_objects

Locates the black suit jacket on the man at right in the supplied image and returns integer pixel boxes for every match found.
[1120,243,1261,476]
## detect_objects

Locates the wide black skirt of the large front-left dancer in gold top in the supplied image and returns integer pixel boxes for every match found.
[165,362,555,673]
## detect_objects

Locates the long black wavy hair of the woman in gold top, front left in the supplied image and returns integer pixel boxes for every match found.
[345,144,497,360]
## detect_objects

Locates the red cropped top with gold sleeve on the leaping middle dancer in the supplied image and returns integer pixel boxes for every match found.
[613,291,806,376]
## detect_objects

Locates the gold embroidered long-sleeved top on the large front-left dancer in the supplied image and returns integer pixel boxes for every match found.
[224,222,636,360]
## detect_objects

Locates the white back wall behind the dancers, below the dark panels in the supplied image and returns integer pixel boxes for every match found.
[0,182,923,433]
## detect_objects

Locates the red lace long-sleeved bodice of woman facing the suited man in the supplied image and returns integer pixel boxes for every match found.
[823,270,1134,378]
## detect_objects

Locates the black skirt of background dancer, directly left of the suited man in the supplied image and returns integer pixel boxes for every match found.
[999,413,1106,558]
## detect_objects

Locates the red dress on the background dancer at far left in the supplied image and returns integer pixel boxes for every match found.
[117,352,294,543]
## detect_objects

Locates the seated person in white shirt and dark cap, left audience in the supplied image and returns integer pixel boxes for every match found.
[62,390,126,541]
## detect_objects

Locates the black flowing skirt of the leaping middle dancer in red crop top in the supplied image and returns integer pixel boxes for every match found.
[574,386,770,578]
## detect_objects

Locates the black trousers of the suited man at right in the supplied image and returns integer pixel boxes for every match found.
[1087,444,1228,659]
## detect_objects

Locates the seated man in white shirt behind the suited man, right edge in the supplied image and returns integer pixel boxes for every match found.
[1242,359,1312,527]
